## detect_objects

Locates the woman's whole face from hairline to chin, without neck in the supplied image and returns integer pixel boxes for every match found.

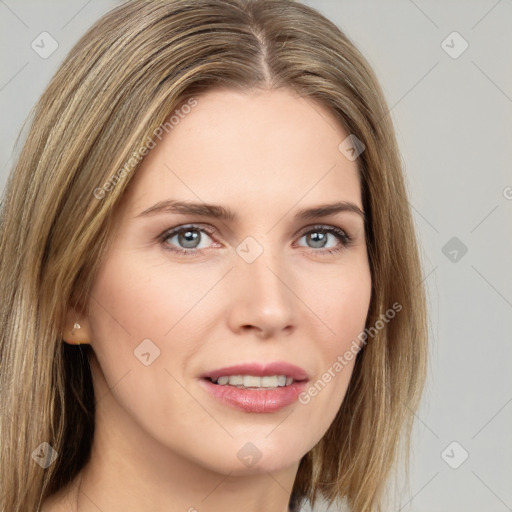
[84,89,371,475]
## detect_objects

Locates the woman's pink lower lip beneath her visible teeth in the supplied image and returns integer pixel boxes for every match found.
[201,379,306,413]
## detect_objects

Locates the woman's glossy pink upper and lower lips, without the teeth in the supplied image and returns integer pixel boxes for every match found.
[200,362,308,413]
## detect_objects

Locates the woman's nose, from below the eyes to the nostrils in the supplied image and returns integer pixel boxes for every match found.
[228,244,298,339]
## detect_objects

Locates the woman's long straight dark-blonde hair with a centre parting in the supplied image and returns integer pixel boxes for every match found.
[0,0,427,512]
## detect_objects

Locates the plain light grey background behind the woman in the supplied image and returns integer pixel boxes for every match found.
[0,0,512,512]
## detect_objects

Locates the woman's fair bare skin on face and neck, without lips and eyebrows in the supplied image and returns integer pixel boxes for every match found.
[42,89,371,512]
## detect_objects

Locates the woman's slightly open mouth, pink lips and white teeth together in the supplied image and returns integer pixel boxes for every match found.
[201,362,309,413]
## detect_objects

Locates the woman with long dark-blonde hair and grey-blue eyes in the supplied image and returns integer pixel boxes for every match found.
[0,0,427,512]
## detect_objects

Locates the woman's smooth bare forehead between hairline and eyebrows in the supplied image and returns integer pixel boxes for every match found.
[120,89,362,215]
